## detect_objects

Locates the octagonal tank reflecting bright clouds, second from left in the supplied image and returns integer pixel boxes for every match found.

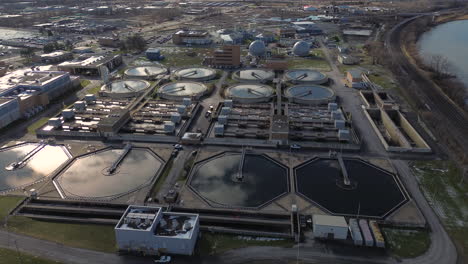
[54,148,163,199]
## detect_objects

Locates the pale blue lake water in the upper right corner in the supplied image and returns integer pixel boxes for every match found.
[419,20,468,89]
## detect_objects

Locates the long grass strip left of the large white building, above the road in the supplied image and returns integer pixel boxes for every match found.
[8,216,117,253]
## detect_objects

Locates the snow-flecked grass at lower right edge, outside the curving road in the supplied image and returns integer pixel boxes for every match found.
[411,161,468,263]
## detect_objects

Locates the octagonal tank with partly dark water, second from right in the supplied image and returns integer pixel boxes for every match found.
[189,152,289,208]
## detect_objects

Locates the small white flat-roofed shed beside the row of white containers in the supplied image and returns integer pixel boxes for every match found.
[312,215,348,240]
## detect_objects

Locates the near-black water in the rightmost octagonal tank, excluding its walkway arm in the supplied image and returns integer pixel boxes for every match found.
[295,159,406,217]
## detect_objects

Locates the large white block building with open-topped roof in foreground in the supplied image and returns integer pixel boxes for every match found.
[115,205,200,255]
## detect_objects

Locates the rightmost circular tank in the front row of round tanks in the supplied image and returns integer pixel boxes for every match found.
[284,84,336,105]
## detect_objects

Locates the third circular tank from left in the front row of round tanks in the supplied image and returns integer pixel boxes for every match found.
[226,83,274,103]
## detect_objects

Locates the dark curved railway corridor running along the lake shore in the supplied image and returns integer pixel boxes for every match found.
[385,14,468,148]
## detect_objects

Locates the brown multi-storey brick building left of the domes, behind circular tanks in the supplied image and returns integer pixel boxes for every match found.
[204,45,241,68]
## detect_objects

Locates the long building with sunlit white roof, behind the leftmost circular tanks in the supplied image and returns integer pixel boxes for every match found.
[57,55,122,76]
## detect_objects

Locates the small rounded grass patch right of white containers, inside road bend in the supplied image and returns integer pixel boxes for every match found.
[382,228,431,258]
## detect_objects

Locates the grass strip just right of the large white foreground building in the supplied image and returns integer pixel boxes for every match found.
[195,232,294,256]
